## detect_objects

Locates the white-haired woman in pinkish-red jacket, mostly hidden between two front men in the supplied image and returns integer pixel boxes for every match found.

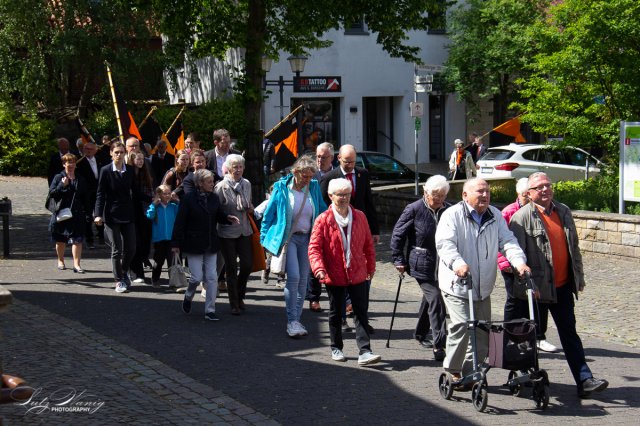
[498,178,559,353]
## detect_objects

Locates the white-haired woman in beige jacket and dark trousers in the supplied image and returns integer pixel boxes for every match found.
[214,154,253,315]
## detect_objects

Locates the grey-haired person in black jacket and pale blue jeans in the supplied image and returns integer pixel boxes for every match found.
[171,169,240,321]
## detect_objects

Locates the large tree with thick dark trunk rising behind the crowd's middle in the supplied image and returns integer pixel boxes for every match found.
[153,0,444,200]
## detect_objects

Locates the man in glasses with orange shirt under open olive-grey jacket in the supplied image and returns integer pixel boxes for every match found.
[510,172,609,398]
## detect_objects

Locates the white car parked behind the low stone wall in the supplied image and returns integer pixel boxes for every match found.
[477,143,602,182]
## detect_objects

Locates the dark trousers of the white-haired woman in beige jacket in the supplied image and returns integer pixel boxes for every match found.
[220,235,253,308]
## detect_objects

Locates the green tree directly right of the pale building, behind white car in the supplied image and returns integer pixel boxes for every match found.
[445,0,549,126]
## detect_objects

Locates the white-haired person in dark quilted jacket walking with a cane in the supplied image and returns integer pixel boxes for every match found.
[391,175,450,361]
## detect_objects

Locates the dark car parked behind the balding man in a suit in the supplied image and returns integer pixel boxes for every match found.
[356,151,431,186]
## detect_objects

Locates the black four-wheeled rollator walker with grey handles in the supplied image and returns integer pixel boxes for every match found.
[438,273,549,412]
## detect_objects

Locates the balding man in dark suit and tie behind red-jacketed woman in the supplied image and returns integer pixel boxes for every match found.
[320,145,380,244]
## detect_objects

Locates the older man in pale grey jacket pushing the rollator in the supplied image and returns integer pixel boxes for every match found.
[436,178,530,380]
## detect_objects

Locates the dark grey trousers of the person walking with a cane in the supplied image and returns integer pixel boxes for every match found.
[414,280,447,349]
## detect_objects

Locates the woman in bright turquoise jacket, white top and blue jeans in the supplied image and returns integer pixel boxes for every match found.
[260,156,327,337]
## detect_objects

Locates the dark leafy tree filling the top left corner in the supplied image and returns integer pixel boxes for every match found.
[0,0,166,110]
